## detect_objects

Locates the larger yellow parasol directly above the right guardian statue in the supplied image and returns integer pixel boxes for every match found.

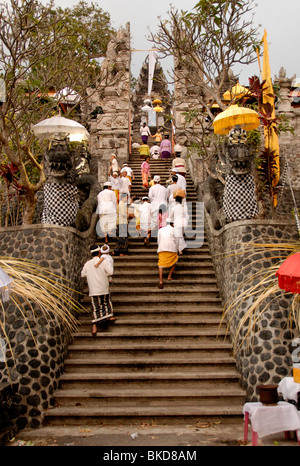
[213,105,260,134]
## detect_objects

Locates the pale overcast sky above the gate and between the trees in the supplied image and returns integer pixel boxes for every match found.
[50,0,300,85]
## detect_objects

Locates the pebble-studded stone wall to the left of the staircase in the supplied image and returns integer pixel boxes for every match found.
[0,216,96,430]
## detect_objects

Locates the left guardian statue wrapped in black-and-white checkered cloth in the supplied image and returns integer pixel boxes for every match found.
[41,139,100,231]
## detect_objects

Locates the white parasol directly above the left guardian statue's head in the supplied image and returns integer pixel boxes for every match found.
[32,116,90,139]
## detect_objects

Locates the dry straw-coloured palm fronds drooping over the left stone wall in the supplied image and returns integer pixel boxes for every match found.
[0,256,84,373]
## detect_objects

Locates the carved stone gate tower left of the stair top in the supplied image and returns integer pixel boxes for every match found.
[84,23,131,185]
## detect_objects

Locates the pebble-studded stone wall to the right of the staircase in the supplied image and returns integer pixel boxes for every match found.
[206,215,299,401]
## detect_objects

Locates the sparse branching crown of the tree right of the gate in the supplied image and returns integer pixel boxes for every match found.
[151,0,258,116]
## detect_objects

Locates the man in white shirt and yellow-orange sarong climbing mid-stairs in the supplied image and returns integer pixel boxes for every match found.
[157,220,178,289]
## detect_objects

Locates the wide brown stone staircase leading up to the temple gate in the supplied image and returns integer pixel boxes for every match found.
[45,146,245,426]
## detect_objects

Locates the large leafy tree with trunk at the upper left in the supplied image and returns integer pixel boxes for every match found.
[0,0,114,224]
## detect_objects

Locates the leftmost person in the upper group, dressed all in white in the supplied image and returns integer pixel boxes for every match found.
[97,181,117,242]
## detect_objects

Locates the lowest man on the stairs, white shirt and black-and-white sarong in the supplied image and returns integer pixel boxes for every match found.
[81,245,115,337]
